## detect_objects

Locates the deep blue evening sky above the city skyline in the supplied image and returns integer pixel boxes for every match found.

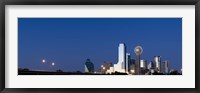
[18,18,182,72]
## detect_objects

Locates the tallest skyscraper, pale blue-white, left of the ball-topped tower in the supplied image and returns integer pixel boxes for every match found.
[114,43,126,73]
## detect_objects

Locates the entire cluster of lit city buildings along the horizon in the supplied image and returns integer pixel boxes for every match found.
[94,43,174,75]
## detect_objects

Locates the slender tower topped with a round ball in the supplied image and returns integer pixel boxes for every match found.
[134,46,143,75]
